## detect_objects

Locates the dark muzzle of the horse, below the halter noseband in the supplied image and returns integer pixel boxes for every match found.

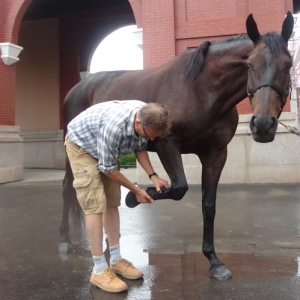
[250,115,278,143]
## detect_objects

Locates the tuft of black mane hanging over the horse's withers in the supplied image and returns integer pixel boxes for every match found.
[186,41,211,81]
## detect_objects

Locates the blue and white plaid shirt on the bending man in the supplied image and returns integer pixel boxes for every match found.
[68,100,148,173]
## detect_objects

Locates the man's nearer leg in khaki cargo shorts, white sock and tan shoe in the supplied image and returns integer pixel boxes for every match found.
[65,138,128,293]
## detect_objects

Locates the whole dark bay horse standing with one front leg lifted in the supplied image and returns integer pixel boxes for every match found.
[60,12,294,279]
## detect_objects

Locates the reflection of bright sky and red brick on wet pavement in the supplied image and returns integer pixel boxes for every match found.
[120,188,300,300]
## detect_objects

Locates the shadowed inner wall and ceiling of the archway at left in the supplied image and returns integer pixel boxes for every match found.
[0,0,135,182]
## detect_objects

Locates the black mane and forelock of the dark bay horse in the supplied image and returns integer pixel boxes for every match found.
[185,31,291,81]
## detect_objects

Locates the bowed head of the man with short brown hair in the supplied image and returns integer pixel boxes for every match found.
[135,103,171,140]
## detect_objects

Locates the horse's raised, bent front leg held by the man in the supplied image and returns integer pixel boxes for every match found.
[126,136,188,208]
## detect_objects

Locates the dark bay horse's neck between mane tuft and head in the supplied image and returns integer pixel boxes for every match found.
[196,38,253,115]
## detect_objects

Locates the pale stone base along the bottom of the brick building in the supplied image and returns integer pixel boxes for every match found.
[0,113,300,185]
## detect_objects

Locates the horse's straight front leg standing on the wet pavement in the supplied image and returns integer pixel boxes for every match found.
[199,147,231,279]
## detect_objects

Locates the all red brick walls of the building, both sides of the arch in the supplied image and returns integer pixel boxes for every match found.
[0,0,293,125]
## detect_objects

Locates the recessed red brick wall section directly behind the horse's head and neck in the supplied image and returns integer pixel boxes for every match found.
[174,0,293,114]
